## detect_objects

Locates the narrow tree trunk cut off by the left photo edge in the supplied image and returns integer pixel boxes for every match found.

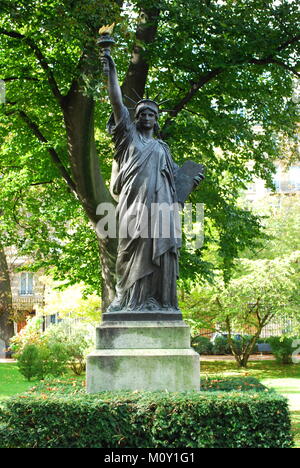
[0,245,14,357]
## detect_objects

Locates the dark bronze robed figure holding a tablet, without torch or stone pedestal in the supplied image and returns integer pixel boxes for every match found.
[101,31,204,320]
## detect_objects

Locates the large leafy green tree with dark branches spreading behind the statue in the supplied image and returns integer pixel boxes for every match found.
[0,0,300,304]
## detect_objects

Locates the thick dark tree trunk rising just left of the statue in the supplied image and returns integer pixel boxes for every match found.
[63,81,117,310]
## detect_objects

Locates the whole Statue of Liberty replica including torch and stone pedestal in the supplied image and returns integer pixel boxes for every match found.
[87,27,204,393]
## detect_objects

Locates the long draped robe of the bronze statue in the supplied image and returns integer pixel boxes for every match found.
[108,107,181,310]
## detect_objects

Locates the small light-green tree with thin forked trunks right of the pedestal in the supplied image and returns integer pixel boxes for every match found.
[183,251,300,367]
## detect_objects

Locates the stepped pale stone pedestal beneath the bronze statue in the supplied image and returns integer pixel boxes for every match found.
[87,320,200,393]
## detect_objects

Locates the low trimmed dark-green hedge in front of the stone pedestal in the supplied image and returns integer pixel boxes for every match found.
[0,392,292,448]
